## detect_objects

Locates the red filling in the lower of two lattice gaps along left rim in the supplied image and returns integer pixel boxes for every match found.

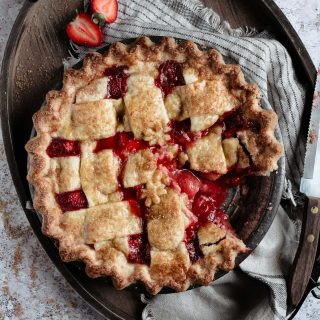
[55,190,88,212]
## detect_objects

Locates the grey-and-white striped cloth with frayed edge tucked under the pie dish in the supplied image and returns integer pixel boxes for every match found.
[67,0,304,320]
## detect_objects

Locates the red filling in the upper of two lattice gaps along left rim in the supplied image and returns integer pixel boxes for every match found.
[47,138,81,158]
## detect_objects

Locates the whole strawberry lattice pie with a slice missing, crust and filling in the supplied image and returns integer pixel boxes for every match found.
[26,37,283,294]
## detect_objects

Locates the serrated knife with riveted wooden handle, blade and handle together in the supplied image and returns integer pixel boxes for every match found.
[289,72,320,306]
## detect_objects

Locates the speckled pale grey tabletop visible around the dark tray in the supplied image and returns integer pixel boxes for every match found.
[0,0,320,320]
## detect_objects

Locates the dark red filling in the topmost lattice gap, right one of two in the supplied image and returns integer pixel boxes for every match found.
[155,60,186,97]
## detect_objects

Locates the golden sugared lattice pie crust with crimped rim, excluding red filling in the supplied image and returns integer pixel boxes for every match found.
[26,37,283,294]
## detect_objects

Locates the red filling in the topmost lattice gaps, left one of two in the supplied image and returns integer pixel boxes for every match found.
[105,66,129,99]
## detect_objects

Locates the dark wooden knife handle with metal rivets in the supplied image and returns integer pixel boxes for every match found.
[288,197,320,306]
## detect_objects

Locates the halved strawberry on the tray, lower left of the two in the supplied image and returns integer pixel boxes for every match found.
[67,13,102,47]
